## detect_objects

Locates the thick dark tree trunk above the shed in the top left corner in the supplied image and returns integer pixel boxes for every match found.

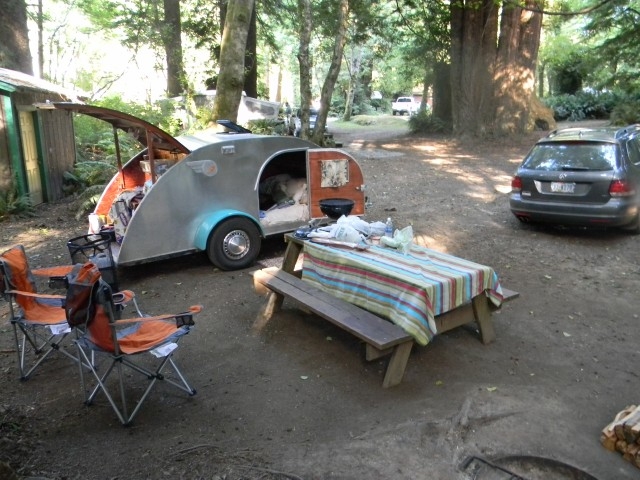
[0,0,33,75]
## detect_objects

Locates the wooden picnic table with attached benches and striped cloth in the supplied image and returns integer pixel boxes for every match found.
[254,234,518,387]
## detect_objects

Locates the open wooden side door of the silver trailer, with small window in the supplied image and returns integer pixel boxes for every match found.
[307,149,365,218]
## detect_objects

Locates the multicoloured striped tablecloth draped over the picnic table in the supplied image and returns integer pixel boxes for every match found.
[302,241,503,345]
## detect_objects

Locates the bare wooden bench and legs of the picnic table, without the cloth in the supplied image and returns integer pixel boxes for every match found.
[253,235,519,388]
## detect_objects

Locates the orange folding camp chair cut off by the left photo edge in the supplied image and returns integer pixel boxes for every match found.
[0,245,77,380]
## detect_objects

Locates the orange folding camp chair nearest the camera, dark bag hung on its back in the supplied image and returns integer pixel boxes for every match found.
[65,262,202,425]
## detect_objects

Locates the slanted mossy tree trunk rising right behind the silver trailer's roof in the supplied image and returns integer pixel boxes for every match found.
[212,0,254,123]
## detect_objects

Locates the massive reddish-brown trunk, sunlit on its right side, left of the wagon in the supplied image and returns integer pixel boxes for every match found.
[451,0,544,136]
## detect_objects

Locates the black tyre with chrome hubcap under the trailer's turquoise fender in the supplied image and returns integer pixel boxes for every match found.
[207,217,262,270]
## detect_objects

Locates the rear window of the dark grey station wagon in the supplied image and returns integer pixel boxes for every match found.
[522,142,617,171]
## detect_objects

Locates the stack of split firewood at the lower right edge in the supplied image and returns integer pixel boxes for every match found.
[600,405,640,468]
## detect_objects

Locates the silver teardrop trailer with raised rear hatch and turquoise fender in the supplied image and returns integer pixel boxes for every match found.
[52,103,365,270]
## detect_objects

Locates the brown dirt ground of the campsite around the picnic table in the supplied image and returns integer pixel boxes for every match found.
[0,117,640,480]
